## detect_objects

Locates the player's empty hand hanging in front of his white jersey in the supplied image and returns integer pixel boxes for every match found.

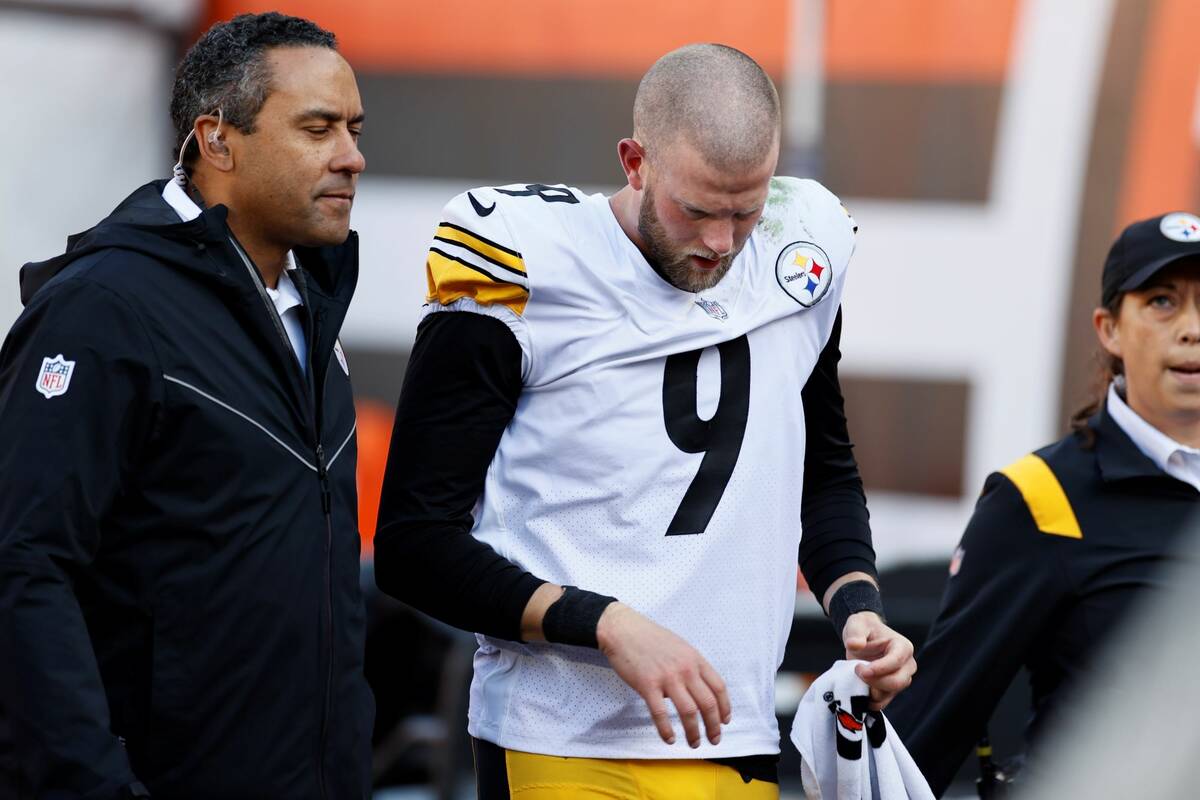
[596,602,733,747]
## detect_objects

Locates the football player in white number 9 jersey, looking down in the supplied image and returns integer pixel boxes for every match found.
[376,44,916,799]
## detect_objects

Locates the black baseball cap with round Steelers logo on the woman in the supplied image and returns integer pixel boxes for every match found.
[1100,211,1200,306]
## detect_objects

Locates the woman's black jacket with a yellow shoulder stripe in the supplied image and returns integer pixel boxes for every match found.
[887,410,1200,796]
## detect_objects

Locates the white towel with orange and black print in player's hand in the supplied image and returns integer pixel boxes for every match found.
[792,661,934,800]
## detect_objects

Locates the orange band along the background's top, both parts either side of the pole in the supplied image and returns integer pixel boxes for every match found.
[201,0,1018,82]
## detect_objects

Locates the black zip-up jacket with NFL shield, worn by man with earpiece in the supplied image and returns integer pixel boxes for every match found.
[0,181,374,800]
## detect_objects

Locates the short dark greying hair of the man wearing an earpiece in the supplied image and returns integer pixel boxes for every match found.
[170,11,337,164]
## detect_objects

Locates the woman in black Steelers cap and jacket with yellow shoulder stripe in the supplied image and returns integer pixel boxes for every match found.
[888,212,1200,795]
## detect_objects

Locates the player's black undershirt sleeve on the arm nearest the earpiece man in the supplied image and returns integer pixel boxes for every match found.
[374,312,544,642]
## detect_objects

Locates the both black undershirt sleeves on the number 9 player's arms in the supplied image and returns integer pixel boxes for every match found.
[374,312,875,640]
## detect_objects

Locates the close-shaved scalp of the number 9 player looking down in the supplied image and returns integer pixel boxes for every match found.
[634,44,780,170]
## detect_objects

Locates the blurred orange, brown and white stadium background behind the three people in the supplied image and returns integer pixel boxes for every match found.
[0,0,1200,798]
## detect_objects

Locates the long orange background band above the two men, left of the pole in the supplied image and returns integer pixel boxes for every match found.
[210,0,788,79]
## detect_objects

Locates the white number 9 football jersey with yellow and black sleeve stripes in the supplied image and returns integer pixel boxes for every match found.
[425,178,854,758]
